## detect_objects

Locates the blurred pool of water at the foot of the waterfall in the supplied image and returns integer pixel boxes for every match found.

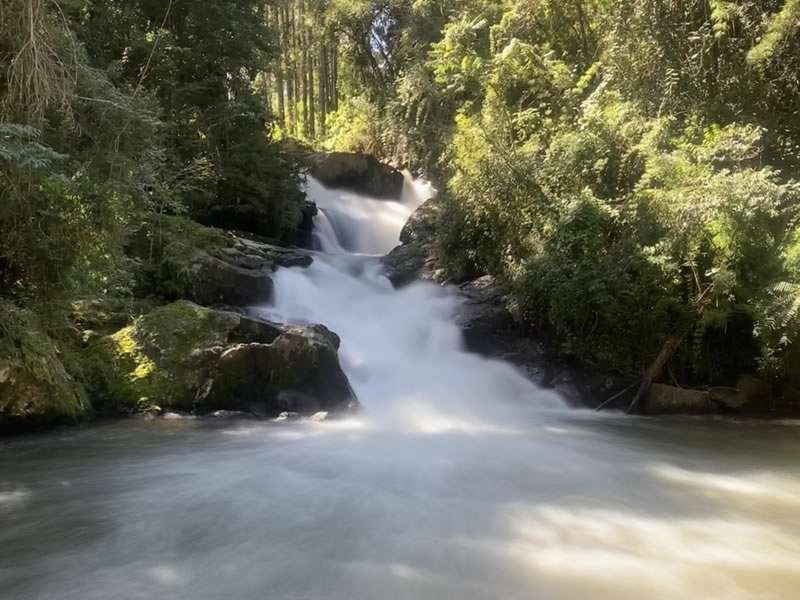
[0,413,800,600]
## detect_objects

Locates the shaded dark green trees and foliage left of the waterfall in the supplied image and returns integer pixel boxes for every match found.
[0,0,303,421]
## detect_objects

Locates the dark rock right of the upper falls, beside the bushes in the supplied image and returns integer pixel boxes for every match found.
[381,198,445,287]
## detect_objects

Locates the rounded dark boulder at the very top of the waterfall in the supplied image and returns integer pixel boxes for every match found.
[311,152,404,200]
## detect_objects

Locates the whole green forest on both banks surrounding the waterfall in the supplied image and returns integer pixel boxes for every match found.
[0,0,800,426]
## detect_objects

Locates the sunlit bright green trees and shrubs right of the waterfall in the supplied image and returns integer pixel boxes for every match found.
[276,0,800,390]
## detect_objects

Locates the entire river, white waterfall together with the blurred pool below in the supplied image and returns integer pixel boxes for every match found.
[0,177,800,600]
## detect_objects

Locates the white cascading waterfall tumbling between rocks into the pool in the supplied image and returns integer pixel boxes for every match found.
[262,179,563,430]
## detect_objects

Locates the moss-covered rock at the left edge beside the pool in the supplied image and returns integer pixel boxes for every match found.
[0,302,91,431]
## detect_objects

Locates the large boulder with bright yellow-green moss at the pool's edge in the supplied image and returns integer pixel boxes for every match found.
[83,301,358,416]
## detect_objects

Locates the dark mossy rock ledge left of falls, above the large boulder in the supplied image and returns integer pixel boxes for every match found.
[129,216,313,306]
